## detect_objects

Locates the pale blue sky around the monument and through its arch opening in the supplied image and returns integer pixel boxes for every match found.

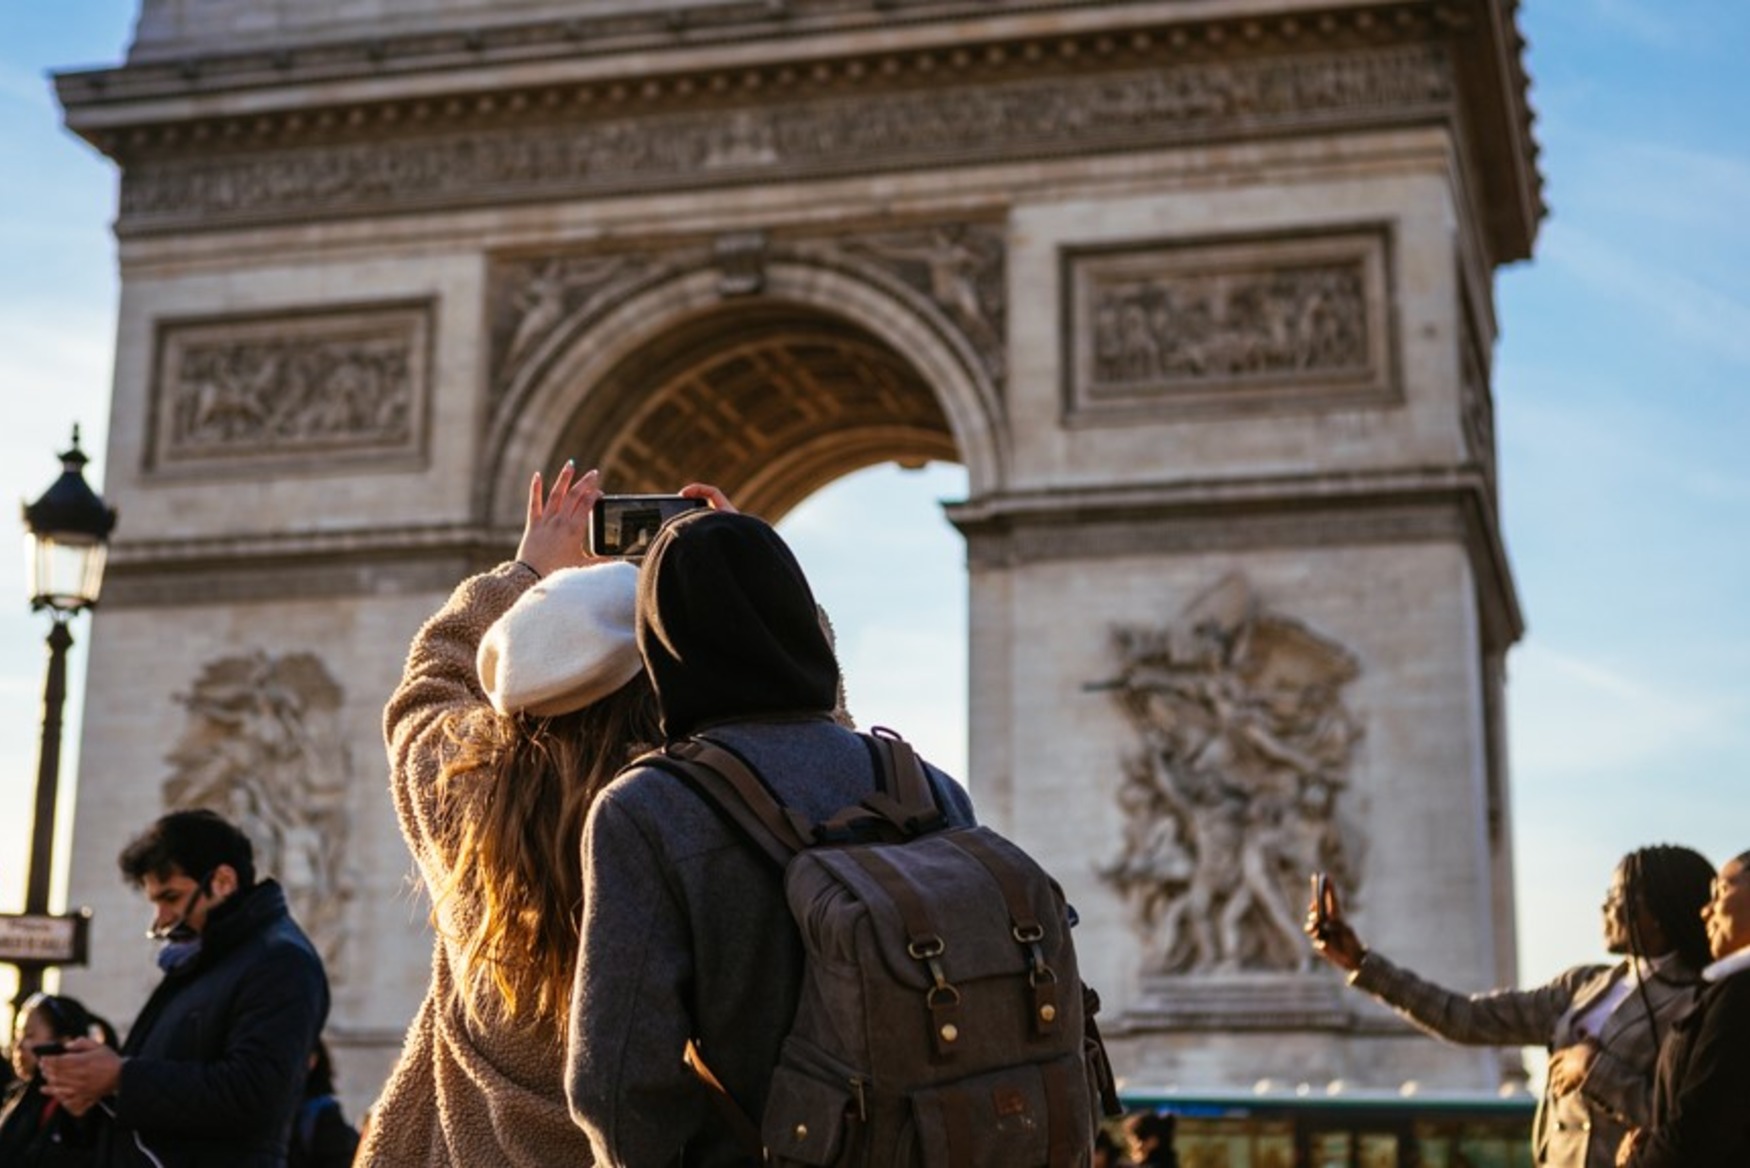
[0,0,1750,1036]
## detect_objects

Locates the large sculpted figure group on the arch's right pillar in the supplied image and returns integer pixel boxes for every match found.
[1101,574,1363,974]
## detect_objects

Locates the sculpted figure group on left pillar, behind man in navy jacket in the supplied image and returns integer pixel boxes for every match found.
[163,650,357,981]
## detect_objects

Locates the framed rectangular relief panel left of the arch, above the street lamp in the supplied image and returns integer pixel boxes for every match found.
[147,303,432,475]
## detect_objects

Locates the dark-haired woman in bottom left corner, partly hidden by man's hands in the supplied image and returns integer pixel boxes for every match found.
[0,993,117,1168]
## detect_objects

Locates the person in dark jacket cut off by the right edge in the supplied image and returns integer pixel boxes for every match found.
[1617,851,1750,1168]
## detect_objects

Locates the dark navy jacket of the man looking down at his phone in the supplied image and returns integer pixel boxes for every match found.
[98,881,329,1168]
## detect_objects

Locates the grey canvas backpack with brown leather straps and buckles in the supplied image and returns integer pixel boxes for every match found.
[646,730,1117,1168]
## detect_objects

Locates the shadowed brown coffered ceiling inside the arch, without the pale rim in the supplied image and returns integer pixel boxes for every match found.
[557,303,961,522]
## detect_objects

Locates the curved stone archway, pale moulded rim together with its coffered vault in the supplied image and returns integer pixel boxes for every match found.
[483,254,1005,522]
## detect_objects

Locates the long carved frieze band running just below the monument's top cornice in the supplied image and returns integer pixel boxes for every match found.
[121,46,1453,231]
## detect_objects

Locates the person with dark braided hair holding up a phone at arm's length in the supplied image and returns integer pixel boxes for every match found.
[1306,844,1713,1168]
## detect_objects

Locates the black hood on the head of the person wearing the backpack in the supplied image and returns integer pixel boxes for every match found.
[639,511,838,739]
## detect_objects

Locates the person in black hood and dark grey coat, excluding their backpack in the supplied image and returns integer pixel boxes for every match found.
[567,510,973,1168]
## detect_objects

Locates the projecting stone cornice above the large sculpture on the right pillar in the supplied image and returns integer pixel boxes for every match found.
[947,468,1524,651]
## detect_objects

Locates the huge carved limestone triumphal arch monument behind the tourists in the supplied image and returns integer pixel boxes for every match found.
[58,0,1542,1113]
